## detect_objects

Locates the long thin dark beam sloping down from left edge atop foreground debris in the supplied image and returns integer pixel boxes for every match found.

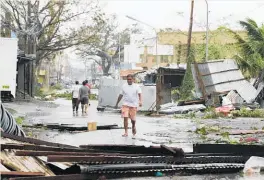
[1,131,77,148]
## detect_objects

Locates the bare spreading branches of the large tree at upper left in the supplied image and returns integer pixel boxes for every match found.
[1,0,100,65]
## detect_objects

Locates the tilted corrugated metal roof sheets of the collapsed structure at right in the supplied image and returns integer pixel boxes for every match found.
[192,59,257,103]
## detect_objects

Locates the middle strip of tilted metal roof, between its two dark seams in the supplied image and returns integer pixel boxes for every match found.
[202,70,244,86]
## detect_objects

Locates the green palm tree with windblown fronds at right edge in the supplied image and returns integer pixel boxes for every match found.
[225,18,264,77]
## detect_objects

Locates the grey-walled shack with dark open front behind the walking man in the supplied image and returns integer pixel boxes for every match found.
[99,65,186,111]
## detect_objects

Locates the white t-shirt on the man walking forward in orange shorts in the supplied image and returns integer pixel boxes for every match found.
[120,83,142,107]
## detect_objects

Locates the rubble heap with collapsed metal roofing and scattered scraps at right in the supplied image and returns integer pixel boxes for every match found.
[160,59,264,114]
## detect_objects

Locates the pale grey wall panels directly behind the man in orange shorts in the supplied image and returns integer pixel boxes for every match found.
[98,78,156,111]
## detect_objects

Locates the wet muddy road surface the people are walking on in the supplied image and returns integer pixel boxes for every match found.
[5,99,264,180]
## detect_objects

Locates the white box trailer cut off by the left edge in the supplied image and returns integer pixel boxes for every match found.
[0,38,18,100]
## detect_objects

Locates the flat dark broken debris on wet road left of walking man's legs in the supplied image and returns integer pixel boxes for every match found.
[22,123,123,131]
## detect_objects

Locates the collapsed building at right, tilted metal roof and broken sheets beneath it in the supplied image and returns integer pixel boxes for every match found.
[192,59,257,106]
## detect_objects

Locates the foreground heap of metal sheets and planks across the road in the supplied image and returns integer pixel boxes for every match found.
[1,132,264,180]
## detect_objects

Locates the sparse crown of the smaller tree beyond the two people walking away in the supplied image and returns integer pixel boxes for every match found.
[77,15,141,75]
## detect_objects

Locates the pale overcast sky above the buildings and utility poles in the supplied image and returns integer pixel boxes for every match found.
[99,0,264,31]
